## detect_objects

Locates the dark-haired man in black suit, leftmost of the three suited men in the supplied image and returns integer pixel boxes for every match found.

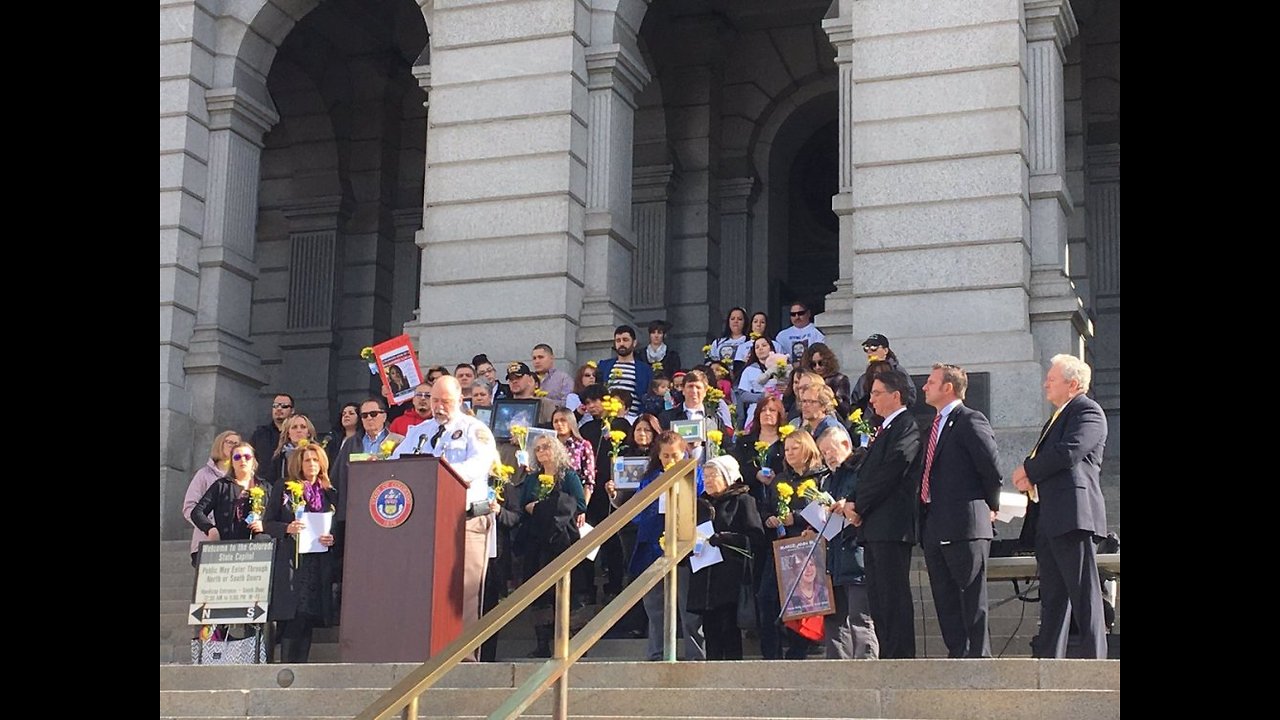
[846,370,920,659]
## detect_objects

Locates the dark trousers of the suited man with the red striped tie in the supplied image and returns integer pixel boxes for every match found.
[924,539,991,657]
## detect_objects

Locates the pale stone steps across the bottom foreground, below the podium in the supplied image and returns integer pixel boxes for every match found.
[160,660,1120,720]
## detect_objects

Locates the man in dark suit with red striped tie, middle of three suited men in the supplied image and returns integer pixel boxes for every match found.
[916,363,1000,657]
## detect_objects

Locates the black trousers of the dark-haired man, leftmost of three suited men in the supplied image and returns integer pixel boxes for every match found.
[863,542,915,660]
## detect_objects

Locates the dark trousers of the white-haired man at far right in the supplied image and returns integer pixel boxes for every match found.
[1032,530,1107,660]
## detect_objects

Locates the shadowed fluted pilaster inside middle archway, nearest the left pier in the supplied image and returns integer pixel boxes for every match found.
[631,165,676,320]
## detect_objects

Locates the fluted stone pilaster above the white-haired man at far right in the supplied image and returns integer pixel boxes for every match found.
[1024,0,1093,365]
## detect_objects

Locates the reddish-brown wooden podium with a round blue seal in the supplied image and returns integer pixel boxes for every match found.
[338,456,467,662]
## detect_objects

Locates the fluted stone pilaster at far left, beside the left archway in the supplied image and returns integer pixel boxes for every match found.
[183,88,279,458]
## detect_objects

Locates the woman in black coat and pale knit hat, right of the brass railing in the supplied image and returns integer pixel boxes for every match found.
[686,455,765,660]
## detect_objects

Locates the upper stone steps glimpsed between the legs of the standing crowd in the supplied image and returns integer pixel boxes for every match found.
[160,541,1120,664]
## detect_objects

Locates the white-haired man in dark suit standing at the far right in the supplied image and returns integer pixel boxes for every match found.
[1014,355,1107,659]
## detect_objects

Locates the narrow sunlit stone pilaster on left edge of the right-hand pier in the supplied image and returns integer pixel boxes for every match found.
[819,14,861,363]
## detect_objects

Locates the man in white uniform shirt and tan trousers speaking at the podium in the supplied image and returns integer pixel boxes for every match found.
[392,375,498,660]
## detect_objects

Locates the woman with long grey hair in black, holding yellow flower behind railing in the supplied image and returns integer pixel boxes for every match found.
[520,436,586,657]
